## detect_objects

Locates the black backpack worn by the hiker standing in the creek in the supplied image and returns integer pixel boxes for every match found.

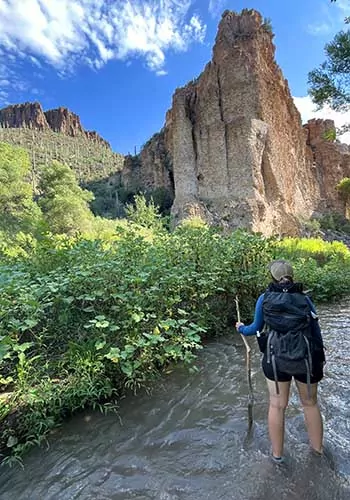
[258,283,313,394]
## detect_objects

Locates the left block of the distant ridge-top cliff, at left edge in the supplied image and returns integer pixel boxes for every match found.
[0,102,49,130]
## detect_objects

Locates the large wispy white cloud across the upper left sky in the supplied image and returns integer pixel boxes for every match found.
[0,0,206,74]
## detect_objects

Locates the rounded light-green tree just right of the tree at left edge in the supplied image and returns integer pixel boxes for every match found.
[39,161,94,235]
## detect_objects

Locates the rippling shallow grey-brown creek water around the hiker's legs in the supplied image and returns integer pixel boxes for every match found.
[0,302,350,500]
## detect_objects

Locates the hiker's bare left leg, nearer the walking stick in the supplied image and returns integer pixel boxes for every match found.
[266,379,290,457]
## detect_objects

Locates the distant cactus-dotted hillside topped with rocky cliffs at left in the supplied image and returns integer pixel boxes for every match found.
[0,103,124,217]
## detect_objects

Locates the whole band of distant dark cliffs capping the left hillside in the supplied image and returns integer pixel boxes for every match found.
[0,102,110,148]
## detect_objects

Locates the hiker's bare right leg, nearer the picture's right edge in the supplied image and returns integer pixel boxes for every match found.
[295,381,323,453]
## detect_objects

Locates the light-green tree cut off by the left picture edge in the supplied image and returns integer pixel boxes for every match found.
[0,143,41,234]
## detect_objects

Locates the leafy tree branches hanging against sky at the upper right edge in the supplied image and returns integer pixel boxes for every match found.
[308,0,350,110]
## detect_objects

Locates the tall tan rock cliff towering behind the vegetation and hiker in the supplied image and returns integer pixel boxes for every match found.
[137,9,348,234]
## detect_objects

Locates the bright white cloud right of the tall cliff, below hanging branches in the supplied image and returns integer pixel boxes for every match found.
[293,96,350,144]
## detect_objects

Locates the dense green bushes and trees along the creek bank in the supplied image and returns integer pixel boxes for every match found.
[0,145,350,463]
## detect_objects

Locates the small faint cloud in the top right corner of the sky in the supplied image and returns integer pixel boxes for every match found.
[307,0,350,36]
